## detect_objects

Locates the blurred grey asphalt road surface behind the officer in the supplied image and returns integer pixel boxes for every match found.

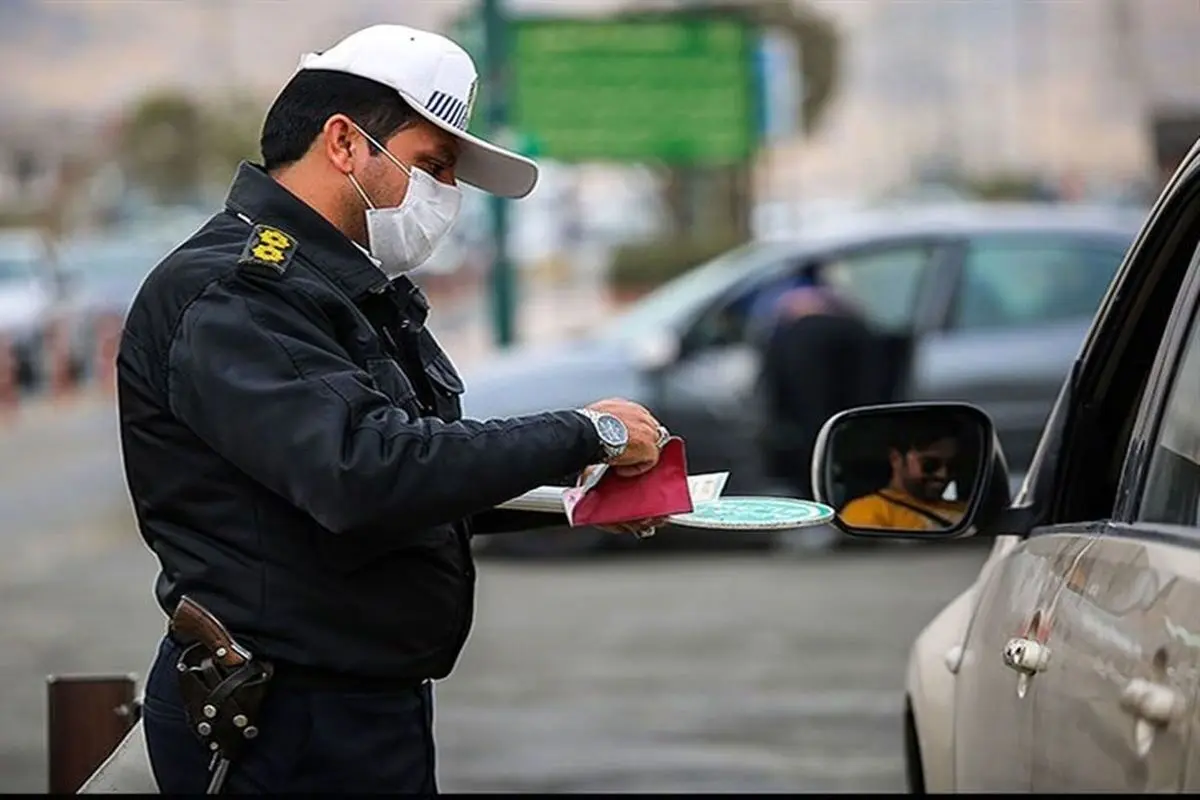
[0,391,984,792]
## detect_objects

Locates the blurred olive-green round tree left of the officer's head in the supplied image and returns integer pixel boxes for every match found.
[116,89,205,203]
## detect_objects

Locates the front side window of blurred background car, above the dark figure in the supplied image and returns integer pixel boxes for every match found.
[822,243,932,332]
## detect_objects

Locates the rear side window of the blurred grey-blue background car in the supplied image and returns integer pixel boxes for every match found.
[950,237,1124,330]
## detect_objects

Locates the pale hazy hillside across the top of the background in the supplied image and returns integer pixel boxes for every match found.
[0,0,1200,206]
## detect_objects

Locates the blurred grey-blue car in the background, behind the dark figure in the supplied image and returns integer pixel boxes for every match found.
[464,204,1144,555]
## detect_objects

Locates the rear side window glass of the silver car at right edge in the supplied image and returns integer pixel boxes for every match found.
[1138,278,1200,527]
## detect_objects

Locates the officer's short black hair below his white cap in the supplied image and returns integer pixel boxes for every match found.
[259,70,420,172]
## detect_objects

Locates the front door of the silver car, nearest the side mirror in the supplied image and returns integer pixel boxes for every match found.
[955,281,1170,792]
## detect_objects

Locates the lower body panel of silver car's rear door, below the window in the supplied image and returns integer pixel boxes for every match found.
[1032,524,1200,794]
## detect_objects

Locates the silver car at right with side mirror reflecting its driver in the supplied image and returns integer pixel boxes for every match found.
[814,137,1200,794]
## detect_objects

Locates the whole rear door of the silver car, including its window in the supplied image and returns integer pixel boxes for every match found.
[1033,235,1200,793]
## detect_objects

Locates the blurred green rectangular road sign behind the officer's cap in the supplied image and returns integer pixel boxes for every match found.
[509,14,758,164]
